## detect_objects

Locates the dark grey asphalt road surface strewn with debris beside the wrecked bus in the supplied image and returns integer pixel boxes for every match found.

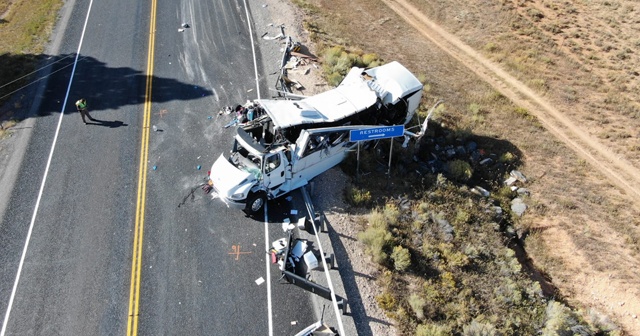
[0,0,317,335]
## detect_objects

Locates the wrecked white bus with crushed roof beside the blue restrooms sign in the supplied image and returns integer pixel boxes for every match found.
[209,62,426,214]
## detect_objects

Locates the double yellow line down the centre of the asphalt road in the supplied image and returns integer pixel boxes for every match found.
[127,0,157,336]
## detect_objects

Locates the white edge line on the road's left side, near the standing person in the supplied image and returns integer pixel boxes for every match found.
[0,0,93,336]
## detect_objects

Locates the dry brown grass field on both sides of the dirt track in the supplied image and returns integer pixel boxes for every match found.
[298,0,640,334]
